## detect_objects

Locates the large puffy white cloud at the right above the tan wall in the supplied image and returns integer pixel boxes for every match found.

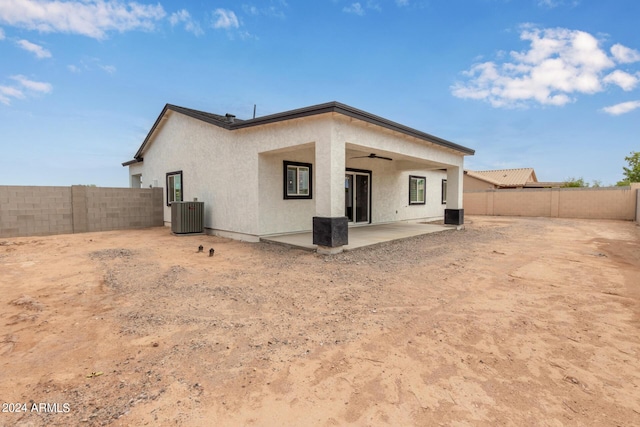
[451,27,638,107]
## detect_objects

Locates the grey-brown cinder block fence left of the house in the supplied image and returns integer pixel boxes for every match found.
[0,185,164,237]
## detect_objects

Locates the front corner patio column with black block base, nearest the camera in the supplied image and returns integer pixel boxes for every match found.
[313,132,348,254]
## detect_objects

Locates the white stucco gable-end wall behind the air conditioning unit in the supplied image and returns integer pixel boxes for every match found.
[129,113,258,234]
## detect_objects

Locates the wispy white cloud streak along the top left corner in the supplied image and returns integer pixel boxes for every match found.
[0,0,166,39]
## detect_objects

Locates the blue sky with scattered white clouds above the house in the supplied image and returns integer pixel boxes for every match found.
[0,0,640,187]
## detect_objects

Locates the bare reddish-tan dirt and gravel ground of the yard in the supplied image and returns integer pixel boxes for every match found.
[0,217,640,426]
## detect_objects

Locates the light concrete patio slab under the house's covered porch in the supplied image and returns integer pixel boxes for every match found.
[260,222,457,251]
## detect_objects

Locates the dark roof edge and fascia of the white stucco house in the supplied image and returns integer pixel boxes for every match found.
[122,101,475,166]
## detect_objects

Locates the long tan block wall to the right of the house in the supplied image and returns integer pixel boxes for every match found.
[464,187,637,220]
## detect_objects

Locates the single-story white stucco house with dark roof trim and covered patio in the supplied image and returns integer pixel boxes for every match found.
[123,102,474,253]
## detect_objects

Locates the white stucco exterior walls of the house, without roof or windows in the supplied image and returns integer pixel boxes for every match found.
[129,111,463,240]
